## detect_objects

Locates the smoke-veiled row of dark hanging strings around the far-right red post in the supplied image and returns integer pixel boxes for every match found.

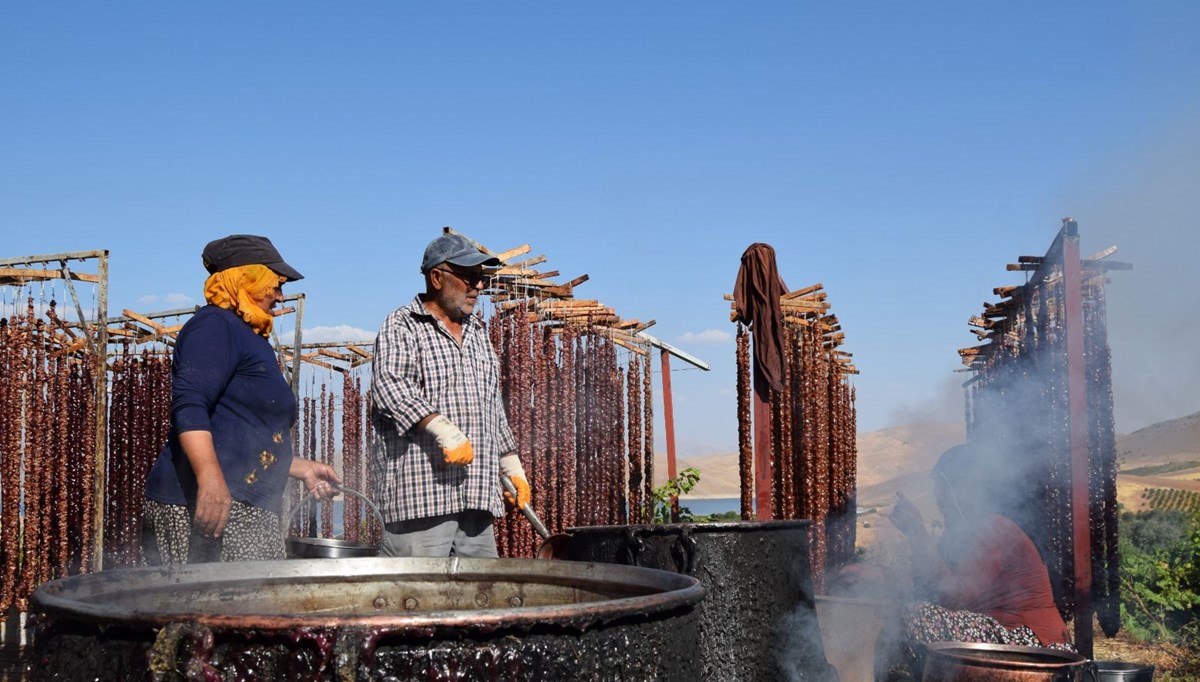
[966,268,1121,636]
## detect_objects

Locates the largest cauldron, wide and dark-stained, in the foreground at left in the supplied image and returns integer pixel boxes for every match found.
[30,558,704,682]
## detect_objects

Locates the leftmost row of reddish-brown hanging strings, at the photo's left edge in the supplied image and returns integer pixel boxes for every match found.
[0,281,102,612]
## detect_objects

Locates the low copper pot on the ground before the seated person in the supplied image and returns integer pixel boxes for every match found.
[922,641,1091,682]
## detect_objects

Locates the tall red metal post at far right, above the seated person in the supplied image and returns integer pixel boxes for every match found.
[1061,219,1094,658]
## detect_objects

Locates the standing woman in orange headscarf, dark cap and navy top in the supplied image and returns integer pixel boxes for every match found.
[143,234,341,564]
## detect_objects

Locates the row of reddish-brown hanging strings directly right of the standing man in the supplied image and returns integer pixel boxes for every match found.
[481,277,654,557]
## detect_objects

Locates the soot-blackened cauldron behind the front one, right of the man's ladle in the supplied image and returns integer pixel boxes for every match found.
[566,520,838,682]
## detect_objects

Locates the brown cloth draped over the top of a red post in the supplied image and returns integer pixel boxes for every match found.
[733,241,787,390]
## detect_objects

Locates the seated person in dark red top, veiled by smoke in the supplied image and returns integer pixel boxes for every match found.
[890,445,1074,651]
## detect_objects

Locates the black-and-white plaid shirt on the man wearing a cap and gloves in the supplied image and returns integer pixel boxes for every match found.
[371,297,517,524]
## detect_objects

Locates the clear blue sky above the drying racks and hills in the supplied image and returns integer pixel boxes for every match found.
[0,0,1200,453]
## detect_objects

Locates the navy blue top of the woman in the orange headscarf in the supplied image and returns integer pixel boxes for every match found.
[146,305,296,513]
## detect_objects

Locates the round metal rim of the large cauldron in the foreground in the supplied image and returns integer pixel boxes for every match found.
[30,557,704,632]
